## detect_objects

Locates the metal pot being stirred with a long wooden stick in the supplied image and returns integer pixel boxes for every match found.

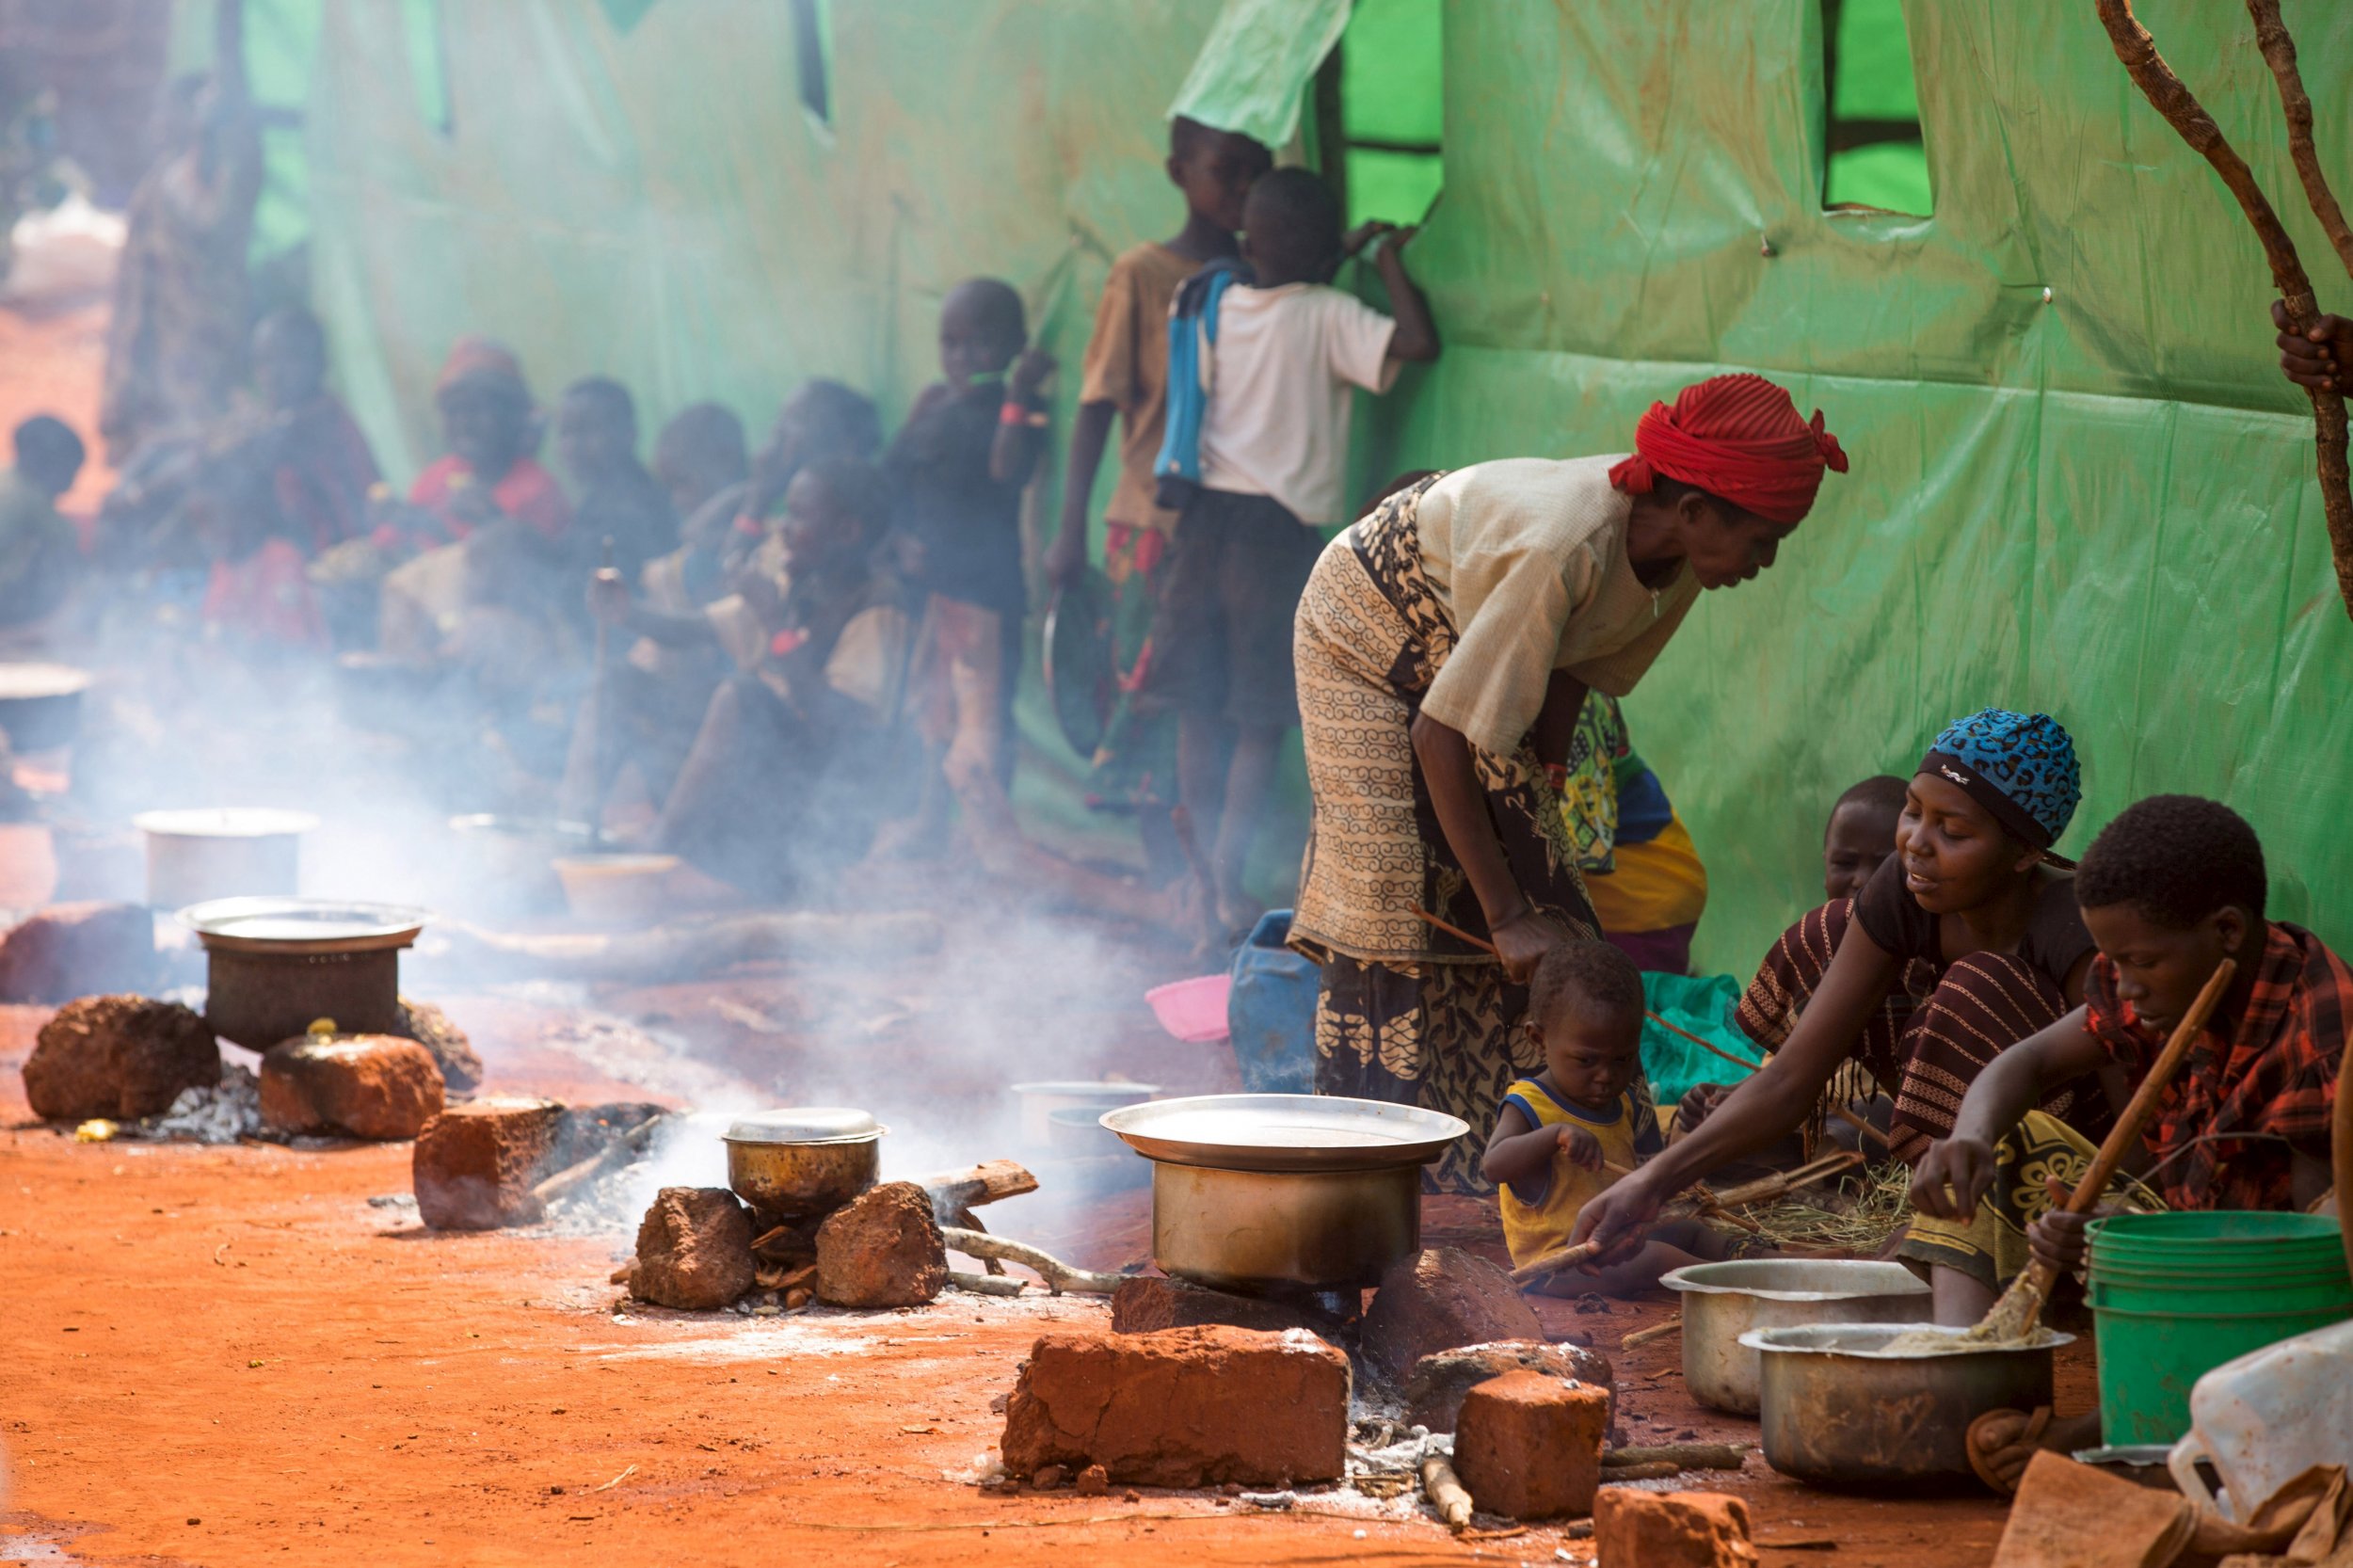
[1741,1323,2073,1485]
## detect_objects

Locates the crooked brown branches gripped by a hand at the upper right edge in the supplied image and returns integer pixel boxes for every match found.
[2094,0,2353,615]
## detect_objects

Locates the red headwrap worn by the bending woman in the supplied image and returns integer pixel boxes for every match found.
[1609,375,1848,522]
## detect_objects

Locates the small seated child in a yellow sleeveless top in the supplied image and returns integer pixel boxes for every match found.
[1481,942,1730,1295]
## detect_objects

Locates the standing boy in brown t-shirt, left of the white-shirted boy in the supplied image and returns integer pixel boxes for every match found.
[1045,116,1273,848]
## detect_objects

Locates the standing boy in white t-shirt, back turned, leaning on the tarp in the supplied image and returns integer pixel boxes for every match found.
[1148,169,1438,930]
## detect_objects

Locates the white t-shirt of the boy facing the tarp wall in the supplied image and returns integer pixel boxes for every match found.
[1200,282,1398,522]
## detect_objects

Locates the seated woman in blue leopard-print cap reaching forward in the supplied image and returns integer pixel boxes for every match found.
[1577,709,2113,1267]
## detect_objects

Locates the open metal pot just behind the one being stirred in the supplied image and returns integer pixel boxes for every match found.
[1659,1257,1929,1415]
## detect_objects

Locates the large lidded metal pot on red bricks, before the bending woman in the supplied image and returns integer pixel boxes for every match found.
[1104,1095,1468,1292]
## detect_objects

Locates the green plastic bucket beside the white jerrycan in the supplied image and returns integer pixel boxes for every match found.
[2089,1210,2353,1448]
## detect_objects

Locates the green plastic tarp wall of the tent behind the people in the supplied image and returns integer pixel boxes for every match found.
[224,0,2353,972]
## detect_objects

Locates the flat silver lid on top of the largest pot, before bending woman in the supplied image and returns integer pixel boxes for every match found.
[1104,1095,1471,1170]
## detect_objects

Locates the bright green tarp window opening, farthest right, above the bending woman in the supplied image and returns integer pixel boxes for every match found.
[1821,0,1934,216]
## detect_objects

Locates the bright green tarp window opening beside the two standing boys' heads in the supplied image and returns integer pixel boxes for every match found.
[1316,0,1445,229]
